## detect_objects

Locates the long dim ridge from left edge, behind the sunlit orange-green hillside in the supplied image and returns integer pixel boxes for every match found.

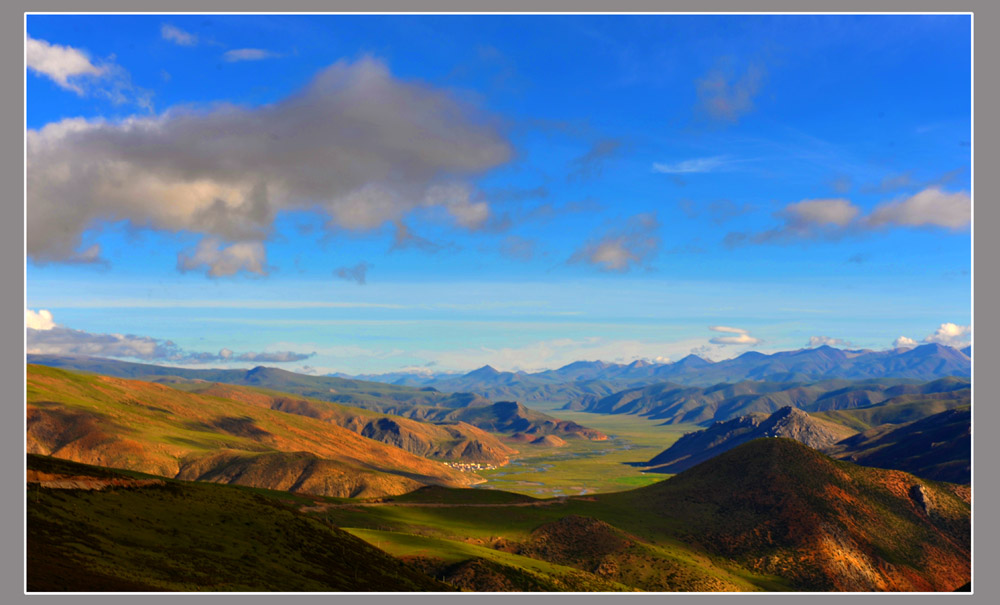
[28,355,607,440]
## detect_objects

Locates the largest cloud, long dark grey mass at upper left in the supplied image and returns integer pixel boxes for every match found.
[27,58,512,266]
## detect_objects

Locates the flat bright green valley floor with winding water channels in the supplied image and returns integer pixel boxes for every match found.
[478,411,701,497]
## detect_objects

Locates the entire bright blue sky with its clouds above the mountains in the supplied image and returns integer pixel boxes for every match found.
[26,15,972,373]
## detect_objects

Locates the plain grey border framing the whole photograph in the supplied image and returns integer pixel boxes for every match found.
[0,0,1000,605]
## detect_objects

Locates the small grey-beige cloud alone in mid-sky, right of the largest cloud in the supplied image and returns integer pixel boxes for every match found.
[569,213,660,273]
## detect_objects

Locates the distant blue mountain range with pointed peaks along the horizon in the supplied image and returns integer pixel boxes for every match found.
[341,344,972,406]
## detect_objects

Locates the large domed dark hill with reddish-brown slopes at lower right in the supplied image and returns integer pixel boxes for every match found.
[599,438,971,591]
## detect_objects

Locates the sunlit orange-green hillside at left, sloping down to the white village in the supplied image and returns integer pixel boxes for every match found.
[27,366,479,496]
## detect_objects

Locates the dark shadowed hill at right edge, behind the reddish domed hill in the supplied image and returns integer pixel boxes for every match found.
[827,408,972,483]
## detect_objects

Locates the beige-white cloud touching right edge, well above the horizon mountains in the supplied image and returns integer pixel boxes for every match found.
[867,187,972,231]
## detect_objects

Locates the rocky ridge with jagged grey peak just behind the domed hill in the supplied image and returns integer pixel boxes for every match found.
[643,407,854,473]
